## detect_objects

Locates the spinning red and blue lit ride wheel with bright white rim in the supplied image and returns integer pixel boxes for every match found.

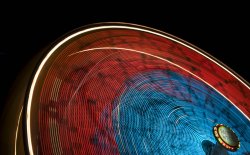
[26,23,250,154]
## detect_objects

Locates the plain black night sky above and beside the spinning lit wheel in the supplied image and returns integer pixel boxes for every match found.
[0,2,250,114]
